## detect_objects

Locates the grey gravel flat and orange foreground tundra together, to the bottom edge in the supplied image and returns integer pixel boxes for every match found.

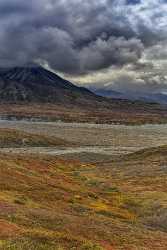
[0,121,167,250]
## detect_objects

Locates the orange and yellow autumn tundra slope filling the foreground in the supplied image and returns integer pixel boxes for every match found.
[0,147,167,250]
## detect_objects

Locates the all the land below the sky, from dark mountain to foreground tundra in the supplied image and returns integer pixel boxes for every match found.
[0,66,167,250]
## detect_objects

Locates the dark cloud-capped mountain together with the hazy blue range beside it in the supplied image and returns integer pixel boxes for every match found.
[0,64,167,108]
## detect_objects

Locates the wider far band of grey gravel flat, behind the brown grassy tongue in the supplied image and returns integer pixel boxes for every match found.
[0,120,167,149]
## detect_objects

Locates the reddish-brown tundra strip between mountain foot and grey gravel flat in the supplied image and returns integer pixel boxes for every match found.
[0,100,167,125]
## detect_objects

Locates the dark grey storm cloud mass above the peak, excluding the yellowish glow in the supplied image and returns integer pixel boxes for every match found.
[0,0,166,79]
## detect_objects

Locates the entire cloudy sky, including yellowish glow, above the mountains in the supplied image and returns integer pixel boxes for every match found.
[0,0,167,93]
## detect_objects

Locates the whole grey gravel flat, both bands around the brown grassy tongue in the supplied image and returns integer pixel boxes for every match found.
[0,120,167,161]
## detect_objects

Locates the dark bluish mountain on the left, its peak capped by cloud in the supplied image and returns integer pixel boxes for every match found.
[0,65,99,104]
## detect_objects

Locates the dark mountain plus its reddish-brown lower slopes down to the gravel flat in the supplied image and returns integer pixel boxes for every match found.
[0,65,167,124]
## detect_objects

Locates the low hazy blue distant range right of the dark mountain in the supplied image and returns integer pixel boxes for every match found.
[89,87,167,104]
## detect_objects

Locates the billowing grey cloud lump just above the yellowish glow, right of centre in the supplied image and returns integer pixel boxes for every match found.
[80,37,143,73]
